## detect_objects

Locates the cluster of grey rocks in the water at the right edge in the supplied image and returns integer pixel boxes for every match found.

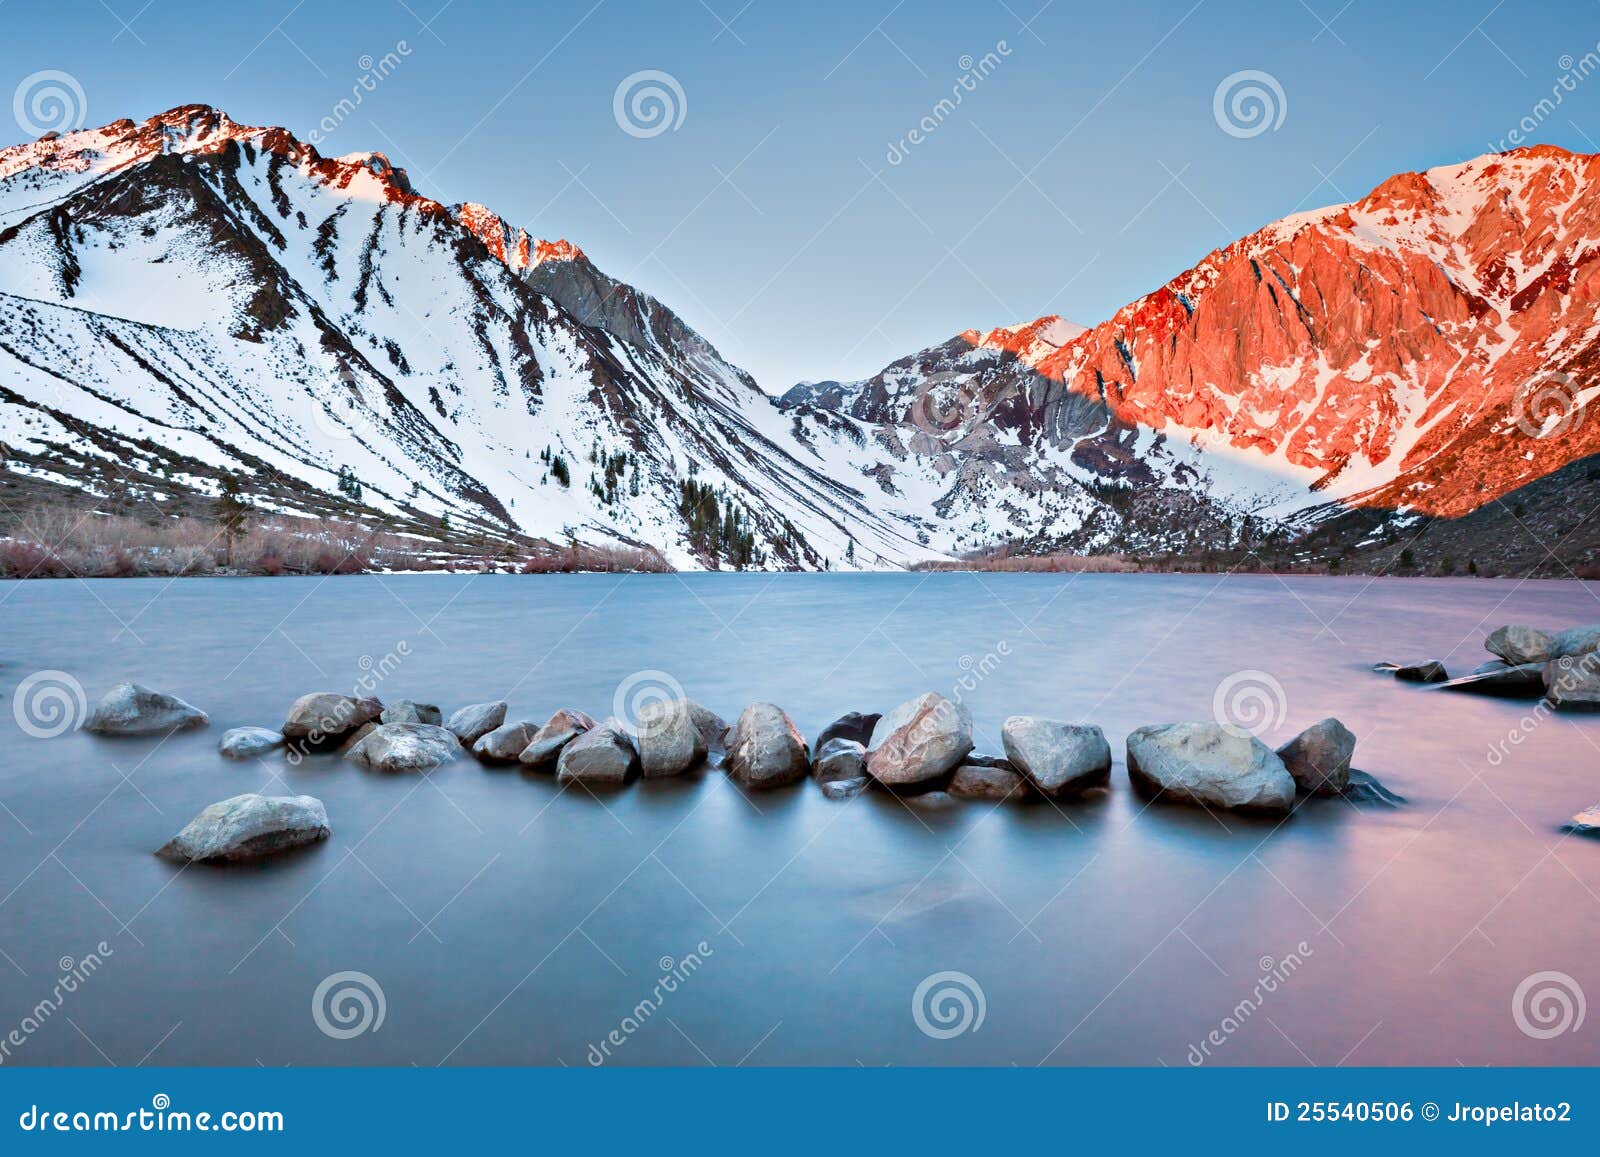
[1374,624,1600,711]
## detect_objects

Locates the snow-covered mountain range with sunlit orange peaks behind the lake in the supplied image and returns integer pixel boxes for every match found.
[0,106,1600,568]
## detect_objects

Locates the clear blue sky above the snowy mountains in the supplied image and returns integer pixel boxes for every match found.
[9,0,1600,390]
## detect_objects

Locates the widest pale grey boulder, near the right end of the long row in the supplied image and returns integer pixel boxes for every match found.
[1128,722,1294,811]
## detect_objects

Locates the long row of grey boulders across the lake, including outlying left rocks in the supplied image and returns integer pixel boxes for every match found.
[72,683,1402,861]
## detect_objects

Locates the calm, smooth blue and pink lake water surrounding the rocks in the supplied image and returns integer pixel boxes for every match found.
[0,574,1600,1066]
